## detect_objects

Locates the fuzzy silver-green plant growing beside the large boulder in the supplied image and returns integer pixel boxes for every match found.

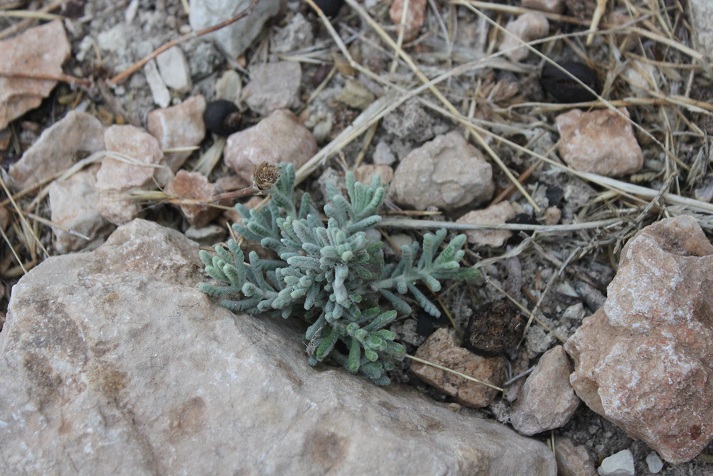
[200,165,478,385]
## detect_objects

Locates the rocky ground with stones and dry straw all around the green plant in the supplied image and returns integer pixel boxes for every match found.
[0,0,713,475]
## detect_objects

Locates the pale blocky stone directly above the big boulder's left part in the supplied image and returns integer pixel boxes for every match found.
[49,166,108,254]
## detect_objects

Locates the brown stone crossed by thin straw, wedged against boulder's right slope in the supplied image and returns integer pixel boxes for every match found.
[411,327,505,408]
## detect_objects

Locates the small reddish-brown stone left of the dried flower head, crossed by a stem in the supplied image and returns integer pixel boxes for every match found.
[166,170,222,228]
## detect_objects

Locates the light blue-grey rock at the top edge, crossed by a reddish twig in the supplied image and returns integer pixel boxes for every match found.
[188,0,280,59]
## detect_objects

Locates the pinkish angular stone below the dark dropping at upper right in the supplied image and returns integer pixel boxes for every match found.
[555,108,644,177]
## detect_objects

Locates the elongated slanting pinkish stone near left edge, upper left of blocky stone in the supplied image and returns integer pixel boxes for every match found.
[8,111,104,190]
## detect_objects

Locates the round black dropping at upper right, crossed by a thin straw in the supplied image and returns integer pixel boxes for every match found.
[540,61,600,103]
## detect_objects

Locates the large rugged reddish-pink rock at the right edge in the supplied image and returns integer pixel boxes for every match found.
[565,216,713,463]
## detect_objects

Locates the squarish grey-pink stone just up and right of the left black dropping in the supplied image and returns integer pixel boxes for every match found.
[243,61,302,116]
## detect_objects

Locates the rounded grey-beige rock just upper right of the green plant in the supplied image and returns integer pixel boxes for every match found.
[390,131,495,210]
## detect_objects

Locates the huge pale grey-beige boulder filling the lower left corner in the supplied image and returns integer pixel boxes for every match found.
[0,220,556,475]
